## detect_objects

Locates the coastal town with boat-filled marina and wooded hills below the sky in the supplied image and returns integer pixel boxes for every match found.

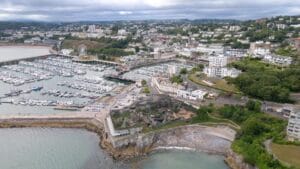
[0,16,300,169]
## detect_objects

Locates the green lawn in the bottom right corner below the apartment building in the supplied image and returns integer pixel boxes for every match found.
[271,143,300,168]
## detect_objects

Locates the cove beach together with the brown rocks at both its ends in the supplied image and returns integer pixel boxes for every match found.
[106,125,257,169]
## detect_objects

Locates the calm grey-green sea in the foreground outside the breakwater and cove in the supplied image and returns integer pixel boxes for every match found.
[0,128,228,169]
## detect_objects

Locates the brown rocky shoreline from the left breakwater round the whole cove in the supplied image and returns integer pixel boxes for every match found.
[0,118,255,169]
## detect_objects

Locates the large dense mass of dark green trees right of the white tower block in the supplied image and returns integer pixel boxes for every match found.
[230,59,300,102]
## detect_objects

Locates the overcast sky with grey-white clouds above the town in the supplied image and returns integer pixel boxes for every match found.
[0,0,300,21]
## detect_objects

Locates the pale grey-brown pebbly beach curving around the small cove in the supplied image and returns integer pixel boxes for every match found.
[154,125,235,155]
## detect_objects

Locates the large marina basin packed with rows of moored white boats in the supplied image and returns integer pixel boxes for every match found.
[0,55,124,114]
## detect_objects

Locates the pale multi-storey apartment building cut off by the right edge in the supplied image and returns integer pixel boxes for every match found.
[287,108,300,141]
